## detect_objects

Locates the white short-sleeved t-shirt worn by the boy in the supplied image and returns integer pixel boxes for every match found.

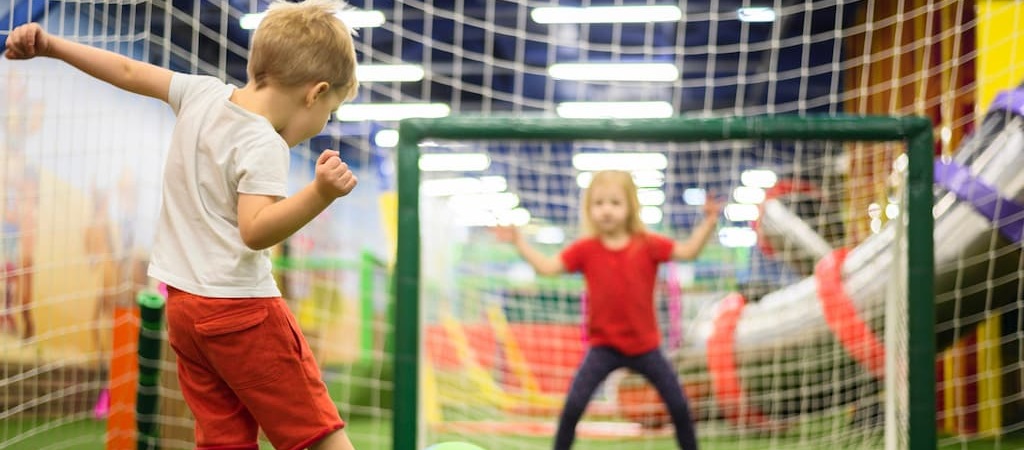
[148,74,289,298]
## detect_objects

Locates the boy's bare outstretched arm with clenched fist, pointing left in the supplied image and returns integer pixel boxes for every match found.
[4,24,173,101]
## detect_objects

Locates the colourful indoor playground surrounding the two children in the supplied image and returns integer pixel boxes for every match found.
[0,0,1024,450]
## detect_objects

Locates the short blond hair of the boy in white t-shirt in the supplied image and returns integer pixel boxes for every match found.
[248,0,359,100]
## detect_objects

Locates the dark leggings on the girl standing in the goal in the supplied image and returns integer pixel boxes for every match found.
[555,346,697,450]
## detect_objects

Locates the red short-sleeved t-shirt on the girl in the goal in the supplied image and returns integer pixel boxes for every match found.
[561,233,675,356]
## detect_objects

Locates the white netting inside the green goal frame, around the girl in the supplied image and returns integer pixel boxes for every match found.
[421,134,906,449]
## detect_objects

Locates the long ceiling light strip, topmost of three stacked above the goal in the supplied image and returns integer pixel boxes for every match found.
[529,5,683,24]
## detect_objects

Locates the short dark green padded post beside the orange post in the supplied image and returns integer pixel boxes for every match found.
[135,290,165,450]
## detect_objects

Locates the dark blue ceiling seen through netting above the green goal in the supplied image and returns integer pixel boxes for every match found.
[86,0,856,113]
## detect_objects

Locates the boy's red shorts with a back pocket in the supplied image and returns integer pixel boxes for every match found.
[167,287,345,450]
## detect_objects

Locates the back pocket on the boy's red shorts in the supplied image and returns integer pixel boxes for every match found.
[196,306,288,390]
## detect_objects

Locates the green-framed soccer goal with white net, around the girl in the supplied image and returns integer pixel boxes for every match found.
[393,116,936,449]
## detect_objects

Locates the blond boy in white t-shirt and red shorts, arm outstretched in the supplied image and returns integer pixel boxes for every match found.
[5,0,358,450]
